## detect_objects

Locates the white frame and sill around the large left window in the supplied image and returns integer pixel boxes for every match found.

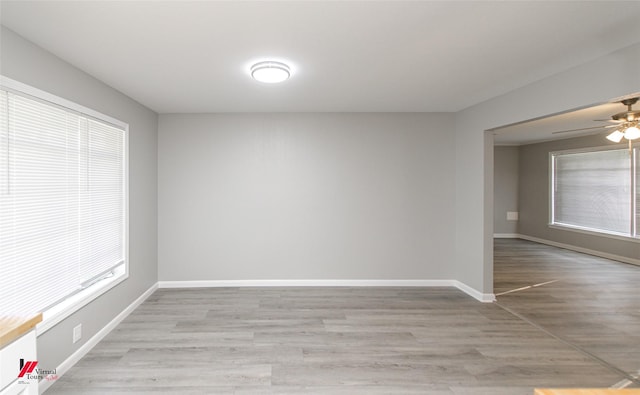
[0,75,129,336]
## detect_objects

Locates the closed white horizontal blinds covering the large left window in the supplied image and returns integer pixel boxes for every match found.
[0,90,126,315]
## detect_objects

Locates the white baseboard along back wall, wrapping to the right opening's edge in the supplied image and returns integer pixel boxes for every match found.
[158,280,495,303]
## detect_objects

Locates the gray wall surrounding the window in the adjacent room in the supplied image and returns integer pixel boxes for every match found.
[519,134,640,259]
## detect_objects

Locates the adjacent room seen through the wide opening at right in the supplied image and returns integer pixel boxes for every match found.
[493,101,640,390]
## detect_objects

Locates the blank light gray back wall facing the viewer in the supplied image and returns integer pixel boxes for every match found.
[158,113,455,280]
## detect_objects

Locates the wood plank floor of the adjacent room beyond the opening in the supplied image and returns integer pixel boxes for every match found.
[494,239,640,386]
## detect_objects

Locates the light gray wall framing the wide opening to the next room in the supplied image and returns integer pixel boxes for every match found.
[455,43,640,293]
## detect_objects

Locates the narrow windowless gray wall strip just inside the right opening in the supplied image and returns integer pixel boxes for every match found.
[493,147,518,234]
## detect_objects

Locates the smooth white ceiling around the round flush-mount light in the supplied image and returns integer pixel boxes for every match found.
[0,0,640,113]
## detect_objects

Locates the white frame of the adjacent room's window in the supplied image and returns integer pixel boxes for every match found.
[547,144,640,243]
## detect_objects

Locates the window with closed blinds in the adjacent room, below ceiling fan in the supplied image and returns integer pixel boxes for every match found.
[551,148,640,238]
